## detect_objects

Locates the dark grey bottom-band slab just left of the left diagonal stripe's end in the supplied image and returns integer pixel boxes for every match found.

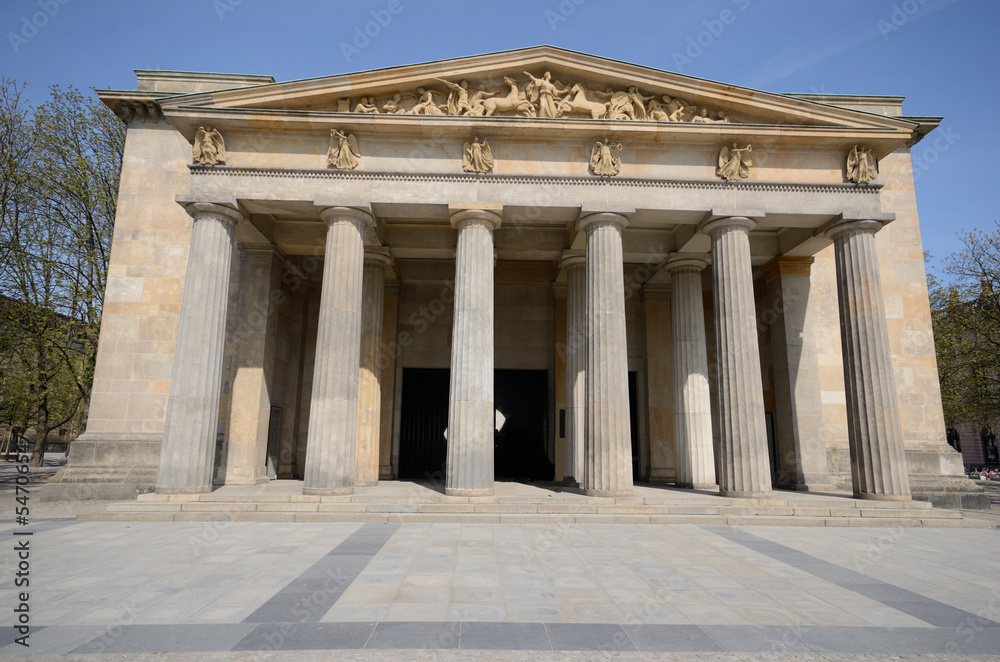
[71,623,253,654]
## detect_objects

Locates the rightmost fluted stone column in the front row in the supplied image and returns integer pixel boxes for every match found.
[826,220,910,501]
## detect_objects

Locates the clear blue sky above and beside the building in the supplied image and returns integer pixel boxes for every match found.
[0,0,1000,272]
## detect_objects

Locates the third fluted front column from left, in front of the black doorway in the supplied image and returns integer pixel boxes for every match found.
[445,209,501,496]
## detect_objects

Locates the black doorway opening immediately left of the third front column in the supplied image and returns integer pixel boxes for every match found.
[399,368,451,482]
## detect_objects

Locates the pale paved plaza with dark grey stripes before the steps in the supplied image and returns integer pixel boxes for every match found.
[0,497,1000,660]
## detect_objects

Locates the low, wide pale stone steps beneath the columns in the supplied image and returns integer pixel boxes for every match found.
[78,481,993,528]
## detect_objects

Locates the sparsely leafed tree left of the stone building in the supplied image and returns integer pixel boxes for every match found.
[0,79,125,466]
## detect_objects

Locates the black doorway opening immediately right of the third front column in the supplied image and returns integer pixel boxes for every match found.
[493,370,555,480]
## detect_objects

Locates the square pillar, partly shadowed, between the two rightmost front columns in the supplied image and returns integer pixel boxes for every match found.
[761,256,834,491]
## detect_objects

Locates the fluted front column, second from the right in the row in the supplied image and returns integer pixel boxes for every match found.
[704,216,771,497]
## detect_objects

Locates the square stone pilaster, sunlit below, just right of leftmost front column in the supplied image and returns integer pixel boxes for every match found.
[224,246,280,485]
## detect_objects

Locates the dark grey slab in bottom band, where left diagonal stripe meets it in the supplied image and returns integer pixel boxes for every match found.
[232,623,375,651]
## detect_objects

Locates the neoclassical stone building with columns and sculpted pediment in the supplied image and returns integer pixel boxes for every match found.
[46,47,982,506]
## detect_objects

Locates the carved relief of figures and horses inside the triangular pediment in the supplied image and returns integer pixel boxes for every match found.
[328,71,732,124]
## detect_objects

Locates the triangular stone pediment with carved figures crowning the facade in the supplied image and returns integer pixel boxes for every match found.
[159,46,914,134]
